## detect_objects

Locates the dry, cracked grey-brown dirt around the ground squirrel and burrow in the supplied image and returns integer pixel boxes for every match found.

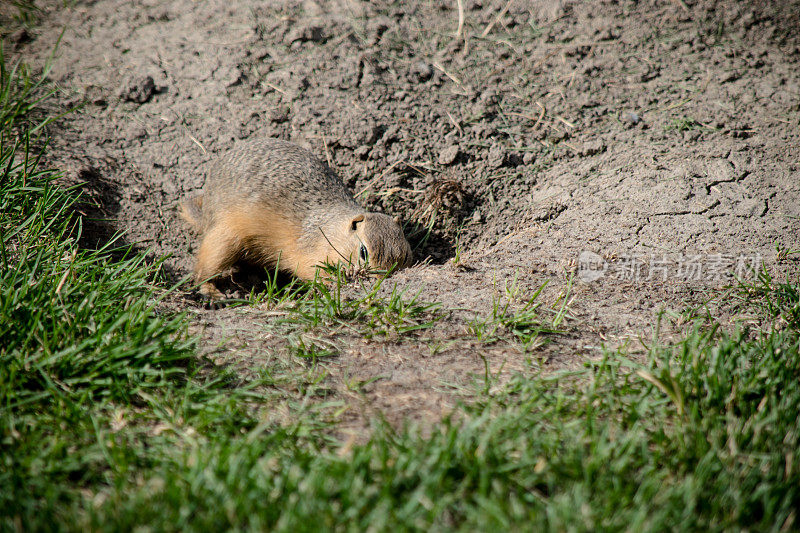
[6,0,800,431]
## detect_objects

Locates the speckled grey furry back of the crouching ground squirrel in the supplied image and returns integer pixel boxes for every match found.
[203,139,359,227]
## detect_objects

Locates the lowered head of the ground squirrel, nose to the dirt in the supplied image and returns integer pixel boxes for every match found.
[332,213,413,271]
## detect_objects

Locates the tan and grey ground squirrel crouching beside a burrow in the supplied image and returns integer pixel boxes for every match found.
[180,139,412,298]
